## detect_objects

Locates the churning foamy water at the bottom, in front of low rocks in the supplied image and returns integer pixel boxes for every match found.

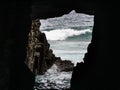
[36,64,72,90]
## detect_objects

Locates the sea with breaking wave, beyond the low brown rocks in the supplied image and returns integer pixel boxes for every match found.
[40,10,94,65]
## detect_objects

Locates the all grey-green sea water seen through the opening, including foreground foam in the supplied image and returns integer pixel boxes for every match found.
[35,10,94,90]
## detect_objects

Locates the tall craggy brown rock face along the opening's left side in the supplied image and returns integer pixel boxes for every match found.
[26,19,57,75]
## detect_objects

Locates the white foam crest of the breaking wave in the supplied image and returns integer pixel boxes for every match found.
[42,29,92,40]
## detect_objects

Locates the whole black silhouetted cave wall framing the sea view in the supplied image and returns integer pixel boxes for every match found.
[0,0,120,90]
